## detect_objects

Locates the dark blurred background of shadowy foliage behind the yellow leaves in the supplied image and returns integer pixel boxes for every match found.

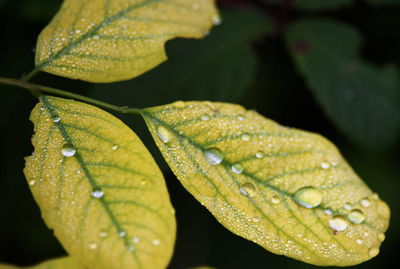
[0,0,400,269]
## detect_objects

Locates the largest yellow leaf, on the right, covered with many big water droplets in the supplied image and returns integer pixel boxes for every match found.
[143,101,390,266]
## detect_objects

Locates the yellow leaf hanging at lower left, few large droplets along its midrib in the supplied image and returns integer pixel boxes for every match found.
[24,96,176,269]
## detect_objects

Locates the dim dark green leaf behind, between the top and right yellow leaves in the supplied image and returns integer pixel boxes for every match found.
[92,8,273,102]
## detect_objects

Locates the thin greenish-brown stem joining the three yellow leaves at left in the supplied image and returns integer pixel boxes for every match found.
[0,77,142,115]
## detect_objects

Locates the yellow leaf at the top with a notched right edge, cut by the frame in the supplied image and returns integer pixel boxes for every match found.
[35,0,219,82]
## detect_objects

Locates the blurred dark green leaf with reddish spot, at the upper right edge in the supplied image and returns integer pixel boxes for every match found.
[286,20,400,149]
